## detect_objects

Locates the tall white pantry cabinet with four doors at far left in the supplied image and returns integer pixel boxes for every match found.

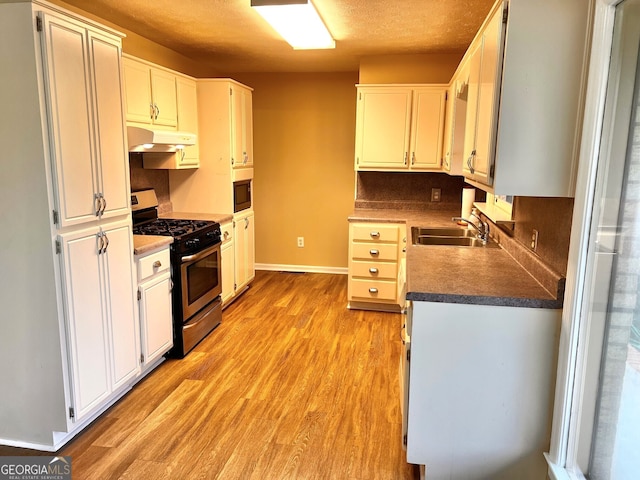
[0,0,140,451]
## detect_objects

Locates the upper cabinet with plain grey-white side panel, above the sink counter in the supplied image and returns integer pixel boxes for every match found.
[454,0,590,197]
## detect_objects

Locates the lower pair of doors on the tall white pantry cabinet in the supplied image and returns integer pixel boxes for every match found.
[59,220,140,421]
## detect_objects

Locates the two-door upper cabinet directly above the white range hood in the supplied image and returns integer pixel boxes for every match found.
[122,56,178,130]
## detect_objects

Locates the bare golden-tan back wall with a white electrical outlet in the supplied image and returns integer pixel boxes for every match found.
[234,72,358,268]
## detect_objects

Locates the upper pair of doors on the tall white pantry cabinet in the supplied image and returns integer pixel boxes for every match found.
[41,13,129,227]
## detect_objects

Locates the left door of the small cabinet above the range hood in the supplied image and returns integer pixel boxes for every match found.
[122,58,153,124]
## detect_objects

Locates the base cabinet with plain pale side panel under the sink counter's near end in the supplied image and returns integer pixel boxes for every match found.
[401,302,561,480]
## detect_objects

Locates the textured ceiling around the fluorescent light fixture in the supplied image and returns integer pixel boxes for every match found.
[64,0,494,72]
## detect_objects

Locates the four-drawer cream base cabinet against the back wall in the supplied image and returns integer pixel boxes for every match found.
[347,222,406,311]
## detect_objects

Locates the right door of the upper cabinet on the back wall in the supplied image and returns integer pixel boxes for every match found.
[411,88,446,170]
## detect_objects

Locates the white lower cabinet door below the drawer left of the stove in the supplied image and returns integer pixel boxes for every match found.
[140,271,173,364]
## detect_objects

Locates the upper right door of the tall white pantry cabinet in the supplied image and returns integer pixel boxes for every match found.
[89,32,130,218]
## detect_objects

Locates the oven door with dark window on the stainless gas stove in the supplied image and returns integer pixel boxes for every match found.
[180,243,222,322]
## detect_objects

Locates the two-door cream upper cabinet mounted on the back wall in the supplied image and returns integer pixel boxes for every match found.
[355,85,446,171]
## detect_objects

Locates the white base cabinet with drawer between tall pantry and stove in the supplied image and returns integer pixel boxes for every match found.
[136,245,173,372]
